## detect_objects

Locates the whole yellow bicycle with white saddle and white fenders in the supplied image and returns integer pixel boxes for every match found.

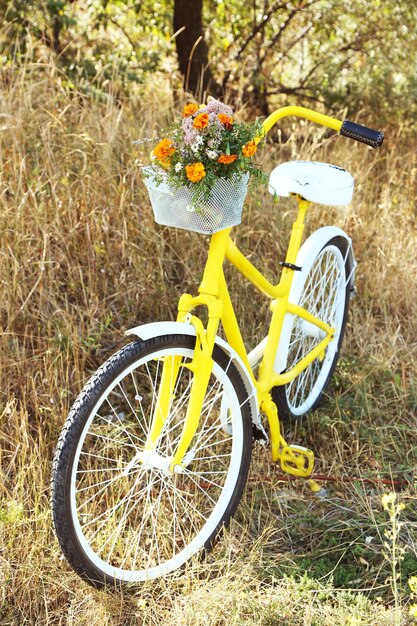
[52,107,383,586]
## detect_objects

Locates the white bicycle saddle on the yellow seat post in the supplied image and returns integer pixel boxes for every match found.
[268,161,354,206]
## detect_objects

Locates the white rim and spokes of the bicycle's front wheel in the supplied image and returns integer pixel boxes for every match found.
[71,348,243,582]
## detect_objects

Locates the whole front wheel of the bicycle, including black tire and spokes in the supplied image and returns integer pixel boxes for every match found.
[52,335,252,586]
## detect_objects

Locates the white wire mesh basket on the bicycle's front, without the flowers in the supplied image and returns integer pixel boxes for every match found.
[142,166,249,234]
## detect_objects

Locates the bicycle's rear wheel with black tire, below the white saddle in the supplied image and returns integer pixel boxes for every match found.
[272,236,353,420]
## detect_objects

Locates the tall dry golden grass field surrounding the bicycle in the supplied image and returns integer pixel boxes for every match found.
[0,57,417,626]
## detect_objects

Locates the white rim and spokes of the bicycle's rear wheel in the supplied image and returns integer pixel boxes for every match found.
[285,245,346,415]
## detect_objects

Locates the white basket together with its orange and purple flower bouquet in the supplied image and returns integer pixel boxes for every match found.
[143,100,265,233]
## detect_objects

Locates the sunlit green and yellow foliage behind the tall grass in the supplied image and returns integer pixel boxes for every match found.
[0,0,417,120]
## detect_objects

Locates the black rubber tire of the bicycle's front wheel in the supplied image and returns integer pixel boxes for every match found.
[51,335,252,588]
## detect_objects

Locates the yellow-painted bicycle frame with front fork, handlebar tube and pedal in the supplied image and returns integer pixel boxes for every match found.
[147,106,342,476]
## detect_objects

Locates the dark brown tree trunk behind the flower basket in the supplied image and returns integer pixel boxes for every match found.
[174,0,222,100]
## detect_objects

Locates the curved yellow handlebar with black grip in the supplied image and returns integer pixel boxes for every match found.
[255,106,384,148]
